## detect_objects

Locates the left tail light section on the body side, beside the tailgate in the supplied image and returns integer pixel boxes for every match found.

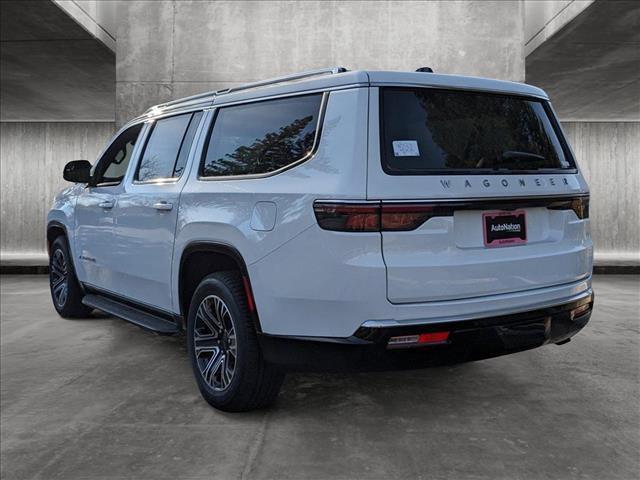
[313,202,380,232]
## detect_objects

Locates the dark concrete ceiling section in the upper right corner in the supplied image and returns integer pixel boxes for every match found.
[526,0,640,121]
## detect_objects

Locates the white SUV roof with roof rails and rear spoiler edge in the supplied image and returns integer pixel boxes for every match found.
[137,67,548,124]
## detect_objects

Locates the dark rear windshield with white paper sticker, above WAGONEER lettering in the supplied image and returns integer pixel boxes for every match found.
[380,87,574,175]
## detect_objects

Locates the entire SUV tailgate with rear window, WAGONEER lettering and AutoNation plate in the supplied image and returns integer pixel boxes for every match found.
[367,87,592,303]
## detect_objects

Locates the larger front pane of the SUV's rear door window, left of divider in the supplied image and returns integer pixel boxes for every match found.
[136,113,192,182]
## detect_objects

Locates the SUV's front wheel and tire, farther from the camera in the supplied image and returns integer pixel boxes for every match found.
[49,236,92,318]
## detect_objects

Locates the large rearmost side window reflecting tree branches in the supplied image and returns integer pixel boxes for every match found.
[200,94,322,177]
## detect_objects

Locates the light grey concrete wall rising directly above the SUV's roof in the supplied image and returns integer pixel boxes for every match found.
[116,0,524,125]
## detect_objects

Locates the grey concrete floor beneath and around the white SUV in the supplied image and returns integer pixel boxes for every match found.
[0,276,640,480]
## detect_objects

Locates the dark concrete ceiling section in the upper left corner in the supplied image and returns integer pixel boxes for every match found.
[0,0,116,121]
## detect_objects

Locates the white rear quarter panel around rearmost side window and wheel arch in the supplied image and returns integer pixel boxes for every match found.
[173,88,368,312]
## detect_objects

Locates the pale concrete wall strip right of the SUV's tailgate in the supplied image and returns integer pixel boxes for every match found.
[562,122,640,265]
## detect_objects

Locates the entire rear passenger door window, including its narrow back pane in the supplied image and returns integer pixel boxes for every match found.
[135,112,202,182]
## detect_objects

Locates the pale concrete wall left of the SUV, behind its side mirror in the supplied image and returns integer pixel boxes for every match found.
[0,122,114,264]
